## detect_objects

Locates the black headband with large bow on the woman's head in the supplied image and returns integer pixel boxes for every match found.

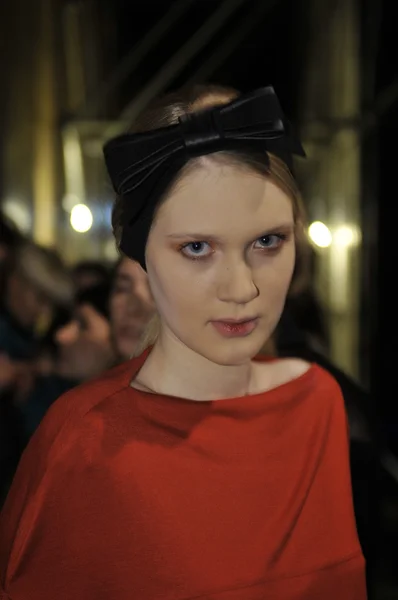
[104,87,305,269]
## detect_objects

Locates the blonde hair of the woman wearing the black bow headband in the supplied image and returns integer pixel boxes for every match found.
[112,85,309,356]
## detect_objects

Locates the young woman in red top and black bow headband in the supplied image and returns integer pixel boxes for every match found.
[0,88,366,600]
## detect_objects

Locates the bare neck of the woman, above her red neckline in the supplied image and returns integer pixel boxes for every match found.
[136,332,252,400]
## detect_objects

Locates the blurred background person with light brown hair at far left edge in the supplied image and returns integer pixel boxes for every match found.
[0,241,73,500]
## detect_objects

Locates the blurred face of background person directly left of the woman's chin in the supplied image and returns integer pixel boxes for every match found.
[110,257,154,360]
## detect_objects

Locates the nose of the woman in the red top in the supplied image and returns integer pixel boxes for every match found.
[218,260,259,304]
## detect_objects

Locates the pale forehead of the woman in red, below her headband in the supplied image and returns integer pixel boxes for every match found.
[155,161,293,233]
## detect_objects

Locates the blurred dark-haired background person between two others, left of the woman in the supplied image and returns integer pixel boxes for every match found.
[19,283,116,438]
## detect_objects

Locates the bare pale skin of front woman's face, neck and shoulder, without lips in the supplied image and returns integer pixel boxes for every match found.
[132,157,309,401]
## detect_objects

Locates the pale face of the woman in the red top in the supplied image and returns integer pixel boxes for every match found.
[146,159,295,365]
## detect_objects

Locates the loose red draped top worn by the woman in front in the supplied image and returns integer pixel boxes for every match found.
[0,356,366,600]
